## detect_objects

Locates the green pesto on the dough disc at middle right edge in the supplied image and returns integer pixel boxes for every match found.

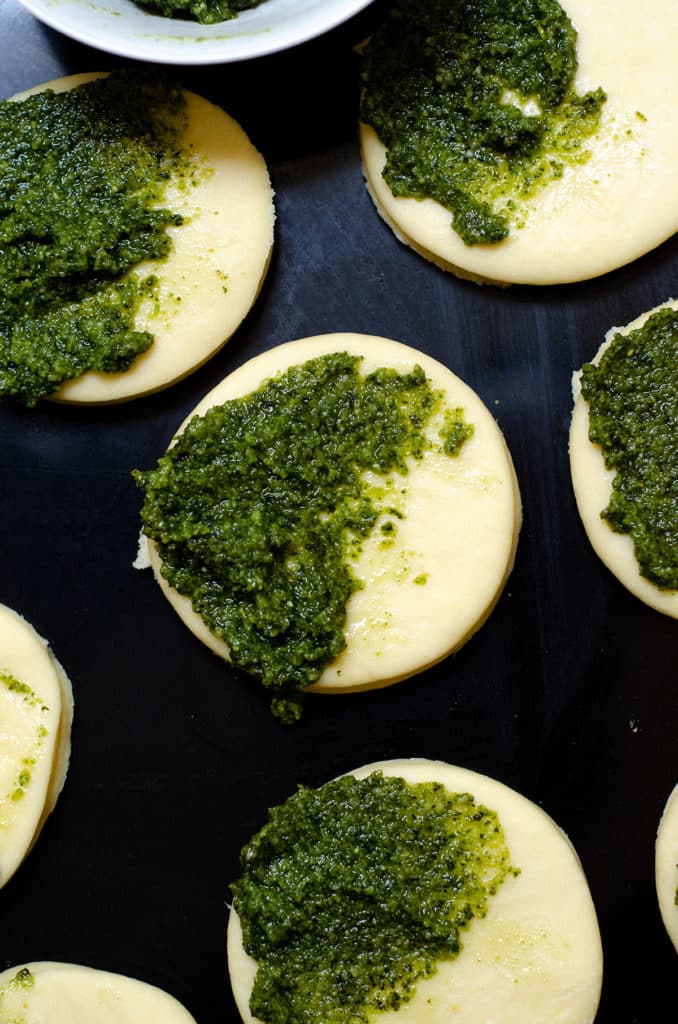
[582,309,678,590]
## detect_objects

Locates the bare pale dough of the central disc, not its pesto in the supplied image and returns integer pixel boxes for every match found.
[150,334,521,693]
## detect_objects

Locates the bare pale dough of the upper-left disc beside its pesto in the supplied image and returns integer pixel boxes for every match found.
[7,75,274,404]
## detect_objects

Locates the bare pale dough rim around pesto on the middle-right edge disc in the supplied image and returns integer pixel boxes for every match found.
[569,299,678,618]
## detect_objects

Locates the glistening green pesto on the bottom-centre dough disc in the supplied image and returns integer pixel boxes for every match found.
[231,772,514,1024]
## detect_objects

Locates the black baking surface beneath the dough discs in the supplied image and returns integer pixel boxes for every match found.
[0,0,678,1024]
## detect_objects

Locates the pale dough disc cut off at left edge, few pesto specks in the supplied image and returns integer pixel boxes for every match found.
[0,605,73,887]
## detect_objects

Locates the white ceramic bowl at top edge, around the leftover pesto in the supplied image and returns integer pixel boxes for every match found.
[17,0,371,65]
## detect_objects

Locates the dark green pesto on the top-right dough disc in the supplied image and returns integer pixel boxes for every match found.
[361,0,605,245]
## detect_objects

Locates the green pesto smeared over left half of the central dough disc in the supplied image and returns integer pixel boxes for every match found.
[135,352,473,721]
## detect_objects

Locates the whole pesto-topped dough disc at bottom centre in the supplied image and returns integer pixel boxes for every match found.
[227,759,602,1024]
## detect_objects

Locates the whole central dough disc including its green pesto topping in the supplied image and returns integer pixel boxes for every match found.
[139,334,521,720]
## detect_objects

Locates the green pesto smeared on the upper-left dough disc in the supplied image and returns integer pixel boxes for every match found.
[0,72,195,406]
